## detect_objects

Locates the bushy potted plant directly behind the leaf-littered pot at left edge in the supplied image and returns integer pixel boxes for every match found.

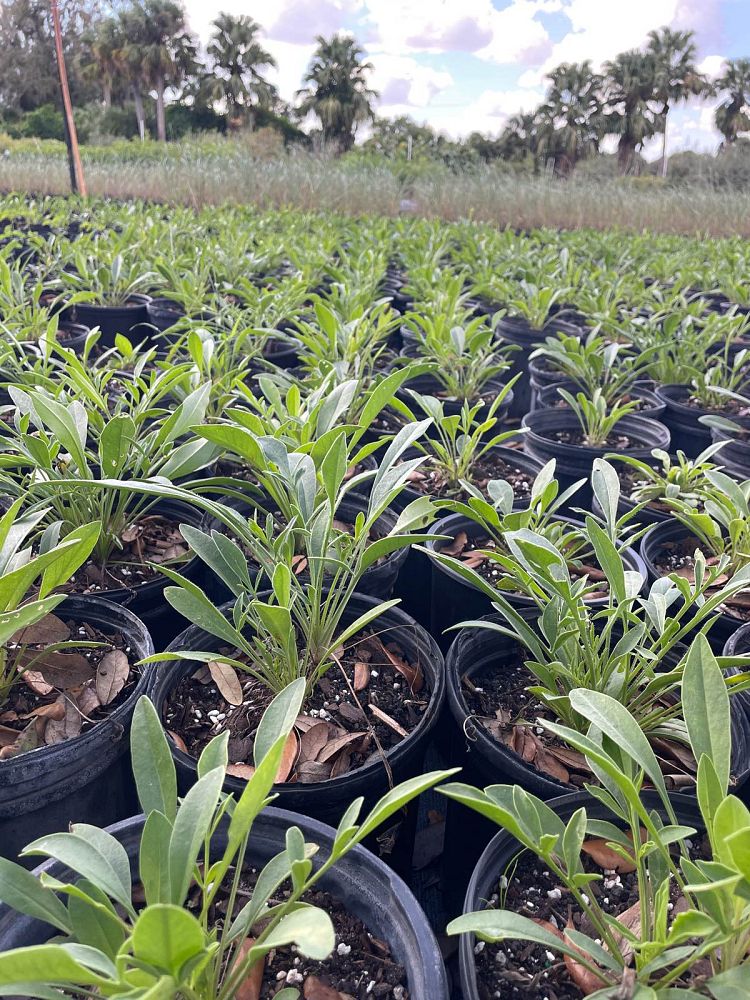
[0,364,217,642]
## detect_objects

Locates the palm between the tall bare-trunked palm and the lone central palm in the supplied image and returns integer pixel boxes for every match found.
[203,14,277,122]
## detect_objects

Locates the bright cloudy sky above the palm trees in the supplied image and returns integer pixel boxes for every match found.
[187,0,750,152]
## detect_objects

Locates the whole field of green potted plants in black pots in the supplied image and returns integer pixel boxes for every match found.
[0,191,750,1000]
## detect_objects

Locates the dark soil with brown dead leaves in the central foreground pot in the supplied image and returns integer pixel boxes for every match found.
[164,631,429,783]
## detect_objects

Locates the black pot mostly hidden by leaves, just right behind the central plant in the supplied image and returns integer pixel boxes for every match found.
[425,514,647,652]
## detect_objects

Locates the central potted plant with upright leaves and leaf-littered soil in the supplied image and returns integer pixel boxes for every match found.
[100,434,444,852]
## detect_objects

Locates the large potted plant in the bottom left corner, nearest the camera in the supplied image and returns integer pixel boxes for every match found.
[0,681,456,1000]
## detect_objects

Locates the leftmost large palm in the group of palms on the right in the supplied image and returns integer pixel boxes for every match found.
[537,59,603,177]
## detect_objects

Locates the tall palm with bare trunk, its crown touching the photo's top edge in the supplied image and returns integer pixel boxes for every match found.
[130,0,197,142]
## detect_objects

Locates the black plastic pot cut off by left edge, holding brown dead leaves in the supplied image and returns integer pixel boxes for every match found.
[0,597,154,864]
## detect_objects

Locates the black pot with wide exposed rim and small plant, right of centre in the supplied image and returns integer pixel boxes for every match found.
[523,409,670,507]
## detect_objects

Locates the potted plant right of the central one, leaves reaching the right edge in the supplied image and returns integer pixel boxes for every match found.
[435,462,750,796]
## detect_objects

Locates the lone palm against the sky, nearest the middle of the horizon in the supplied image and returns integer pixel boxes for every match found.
[297,35,378,152]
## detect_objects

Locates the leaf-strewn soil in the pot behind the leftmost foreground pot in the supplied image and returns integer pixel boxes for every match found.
[66,514,190,594]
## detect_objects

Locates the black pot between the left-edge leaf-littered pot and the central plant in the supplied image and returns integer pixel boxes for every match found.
[90,498,203,652]
